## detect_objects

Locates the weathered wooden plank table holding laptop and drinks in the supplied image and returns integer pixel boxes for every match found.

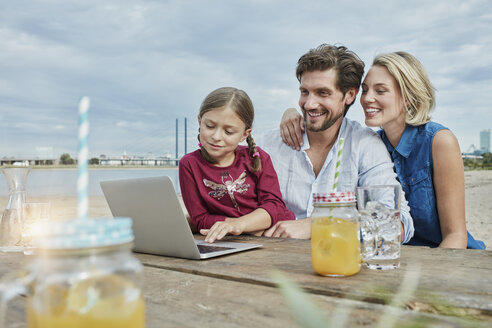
[0,236,492,327]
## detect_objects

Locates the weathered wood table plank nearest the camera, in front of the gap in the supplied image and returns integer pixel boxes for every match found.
[0,253,486,327]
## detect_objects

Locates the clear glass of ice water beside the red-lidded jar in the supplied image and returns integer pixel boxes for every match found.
[357,185,401,270]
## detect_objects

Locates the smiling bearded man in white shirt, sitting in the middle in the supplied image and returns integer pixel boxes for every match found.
[256,44,414,242]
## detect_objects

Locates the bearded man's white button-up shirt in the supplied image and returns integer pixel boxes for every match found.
[255,118,414,242]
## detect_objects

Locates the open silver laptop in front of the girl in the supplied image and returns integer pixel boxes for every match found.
[101,176,263,260]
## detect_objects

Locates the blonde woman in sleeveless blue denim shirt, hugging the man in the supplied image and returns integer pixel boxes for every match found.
[282,52,485,249]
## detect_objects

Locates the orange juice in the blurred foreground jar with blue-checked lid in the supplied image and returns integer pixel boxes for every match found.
[27,275,145,328]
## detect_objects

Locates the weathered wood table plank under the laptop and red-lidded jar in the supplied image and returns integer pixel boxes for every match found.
[137,236,492,321]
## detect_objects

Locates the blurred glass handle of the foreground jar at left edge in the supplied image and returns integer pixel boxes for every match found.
[0,270,34,328]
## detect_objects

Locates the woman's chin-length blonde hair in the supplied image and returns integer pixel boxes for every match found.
[372,51,435,125]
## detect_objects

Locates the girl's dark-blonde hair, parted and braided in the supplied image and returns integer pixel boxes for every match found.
[198,87,261,172]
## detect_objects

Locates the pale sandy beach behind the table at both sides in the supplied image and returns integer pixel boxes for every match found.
[0,171,492,250]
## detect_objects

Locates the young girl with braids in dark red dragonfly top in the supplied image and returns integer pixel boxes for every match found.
[179,88,295,243]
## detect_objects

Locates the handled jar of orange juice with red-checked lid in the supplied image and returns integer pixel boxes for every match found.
[311,192,376,276]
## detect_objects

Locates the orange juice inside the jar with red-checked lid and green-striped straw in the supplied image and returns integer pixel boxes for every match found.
[311,217,361,276]
